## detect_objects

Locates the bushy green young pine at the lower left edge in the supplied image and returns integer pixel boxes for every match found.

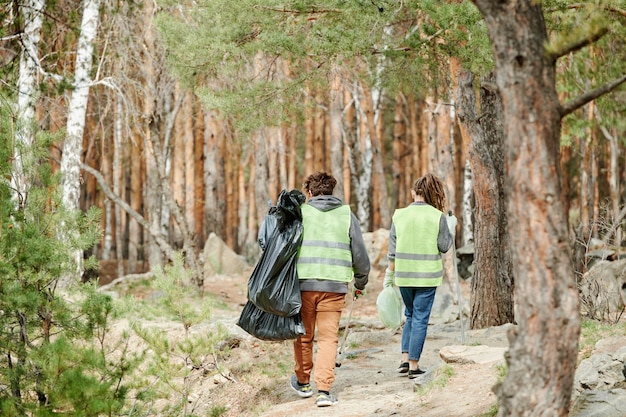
[0,106,137,416]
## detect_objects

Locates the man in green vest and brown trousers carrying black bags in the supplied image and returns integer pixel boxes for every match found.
[290,172,370,407]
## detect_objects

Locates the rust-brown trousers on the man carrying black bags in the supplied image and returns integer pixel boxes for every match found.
[293,291,346,391]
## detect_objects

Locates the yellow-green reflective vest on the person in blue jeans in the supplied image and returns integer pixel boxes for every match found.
[393,204,443,287]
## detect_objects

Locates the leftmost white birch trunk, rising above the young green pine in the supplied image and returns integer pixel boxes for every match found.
[11,0,46,206]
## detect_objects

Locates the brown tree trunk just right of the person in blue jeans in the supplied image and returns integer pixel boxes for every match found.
[457,71,514,329]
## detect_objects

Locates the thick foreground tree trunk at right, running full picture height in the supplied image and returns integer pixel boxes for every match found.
[474,0,580,416]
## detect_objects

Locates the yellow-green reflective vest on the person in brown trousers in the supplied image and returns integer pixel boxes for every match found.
[297,204,353,282]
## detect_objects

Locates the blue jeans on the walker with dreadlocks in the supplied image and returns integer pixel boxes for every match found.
[400,287,437,361]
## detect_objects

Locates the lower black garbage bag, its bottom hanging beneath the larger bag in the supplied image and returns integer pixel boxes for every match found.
[237,301,306,341]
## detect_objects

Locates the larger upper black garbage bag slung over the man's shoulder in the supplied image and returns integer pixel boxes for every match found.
[248,190,304,317]
